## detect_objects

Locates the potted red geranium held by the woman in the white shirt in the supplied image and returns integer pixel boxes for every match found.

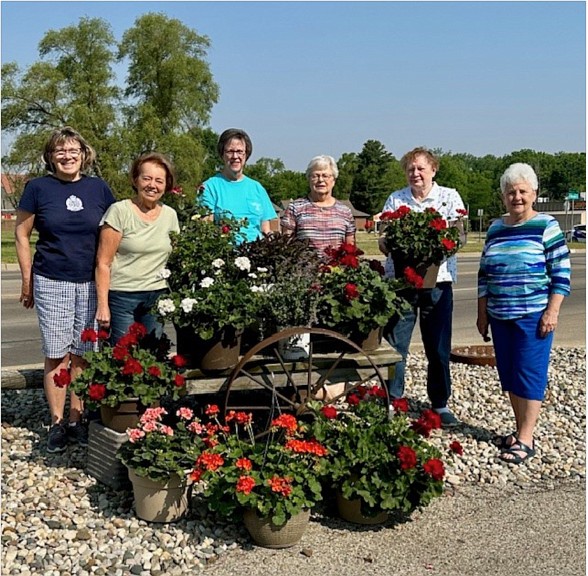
[380,206,467,288]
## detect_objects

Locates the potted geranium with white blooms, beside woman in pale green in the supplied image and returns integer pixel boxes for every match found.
[156,208,258,371]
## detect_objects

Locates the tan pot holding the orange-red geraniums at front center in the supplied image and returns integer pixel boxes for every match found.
[243,510,310,548]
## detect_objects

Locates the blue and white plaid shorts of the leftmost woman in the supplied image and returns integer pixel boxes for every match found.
[33,274,97,358]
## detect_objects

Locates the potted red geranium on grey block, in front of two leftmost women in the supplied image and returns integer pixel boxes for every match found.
[66,322,185,432]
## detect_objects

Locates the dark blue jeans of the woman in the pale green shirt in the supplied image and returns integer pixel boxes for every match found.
[108,289,167,345]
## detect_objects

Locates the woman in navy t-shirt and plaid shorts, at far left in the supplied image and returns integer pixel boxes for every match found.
[15,126,115,452]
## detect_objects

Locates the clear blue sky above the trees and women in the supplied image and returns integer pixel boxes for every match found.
[1,1,586,171]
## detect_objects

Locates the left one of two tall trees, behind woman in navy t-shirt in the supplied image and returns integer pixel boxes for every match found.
[2,18,118,177]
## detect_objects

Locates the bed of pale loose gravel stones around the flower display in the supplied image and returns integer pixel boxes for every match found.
[2,348,586,576]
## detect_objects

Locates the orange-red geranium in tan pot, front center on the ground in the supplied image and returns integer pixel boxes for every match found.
[191,406,327,547]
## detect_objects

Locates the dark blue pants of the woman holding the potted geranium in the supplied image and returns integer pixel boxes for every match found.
[384,282,453,408]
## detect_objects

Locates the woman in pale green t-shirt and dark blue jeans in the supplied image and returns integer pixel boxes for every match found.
[96,152,180,344]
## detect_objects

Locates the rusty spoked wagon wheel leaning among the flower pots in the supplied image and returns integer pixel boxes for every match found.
[223,327,389,435]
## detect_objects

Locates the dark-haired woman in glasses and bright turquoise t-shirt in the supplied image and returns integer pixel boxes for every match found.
[199,128,278,241]
